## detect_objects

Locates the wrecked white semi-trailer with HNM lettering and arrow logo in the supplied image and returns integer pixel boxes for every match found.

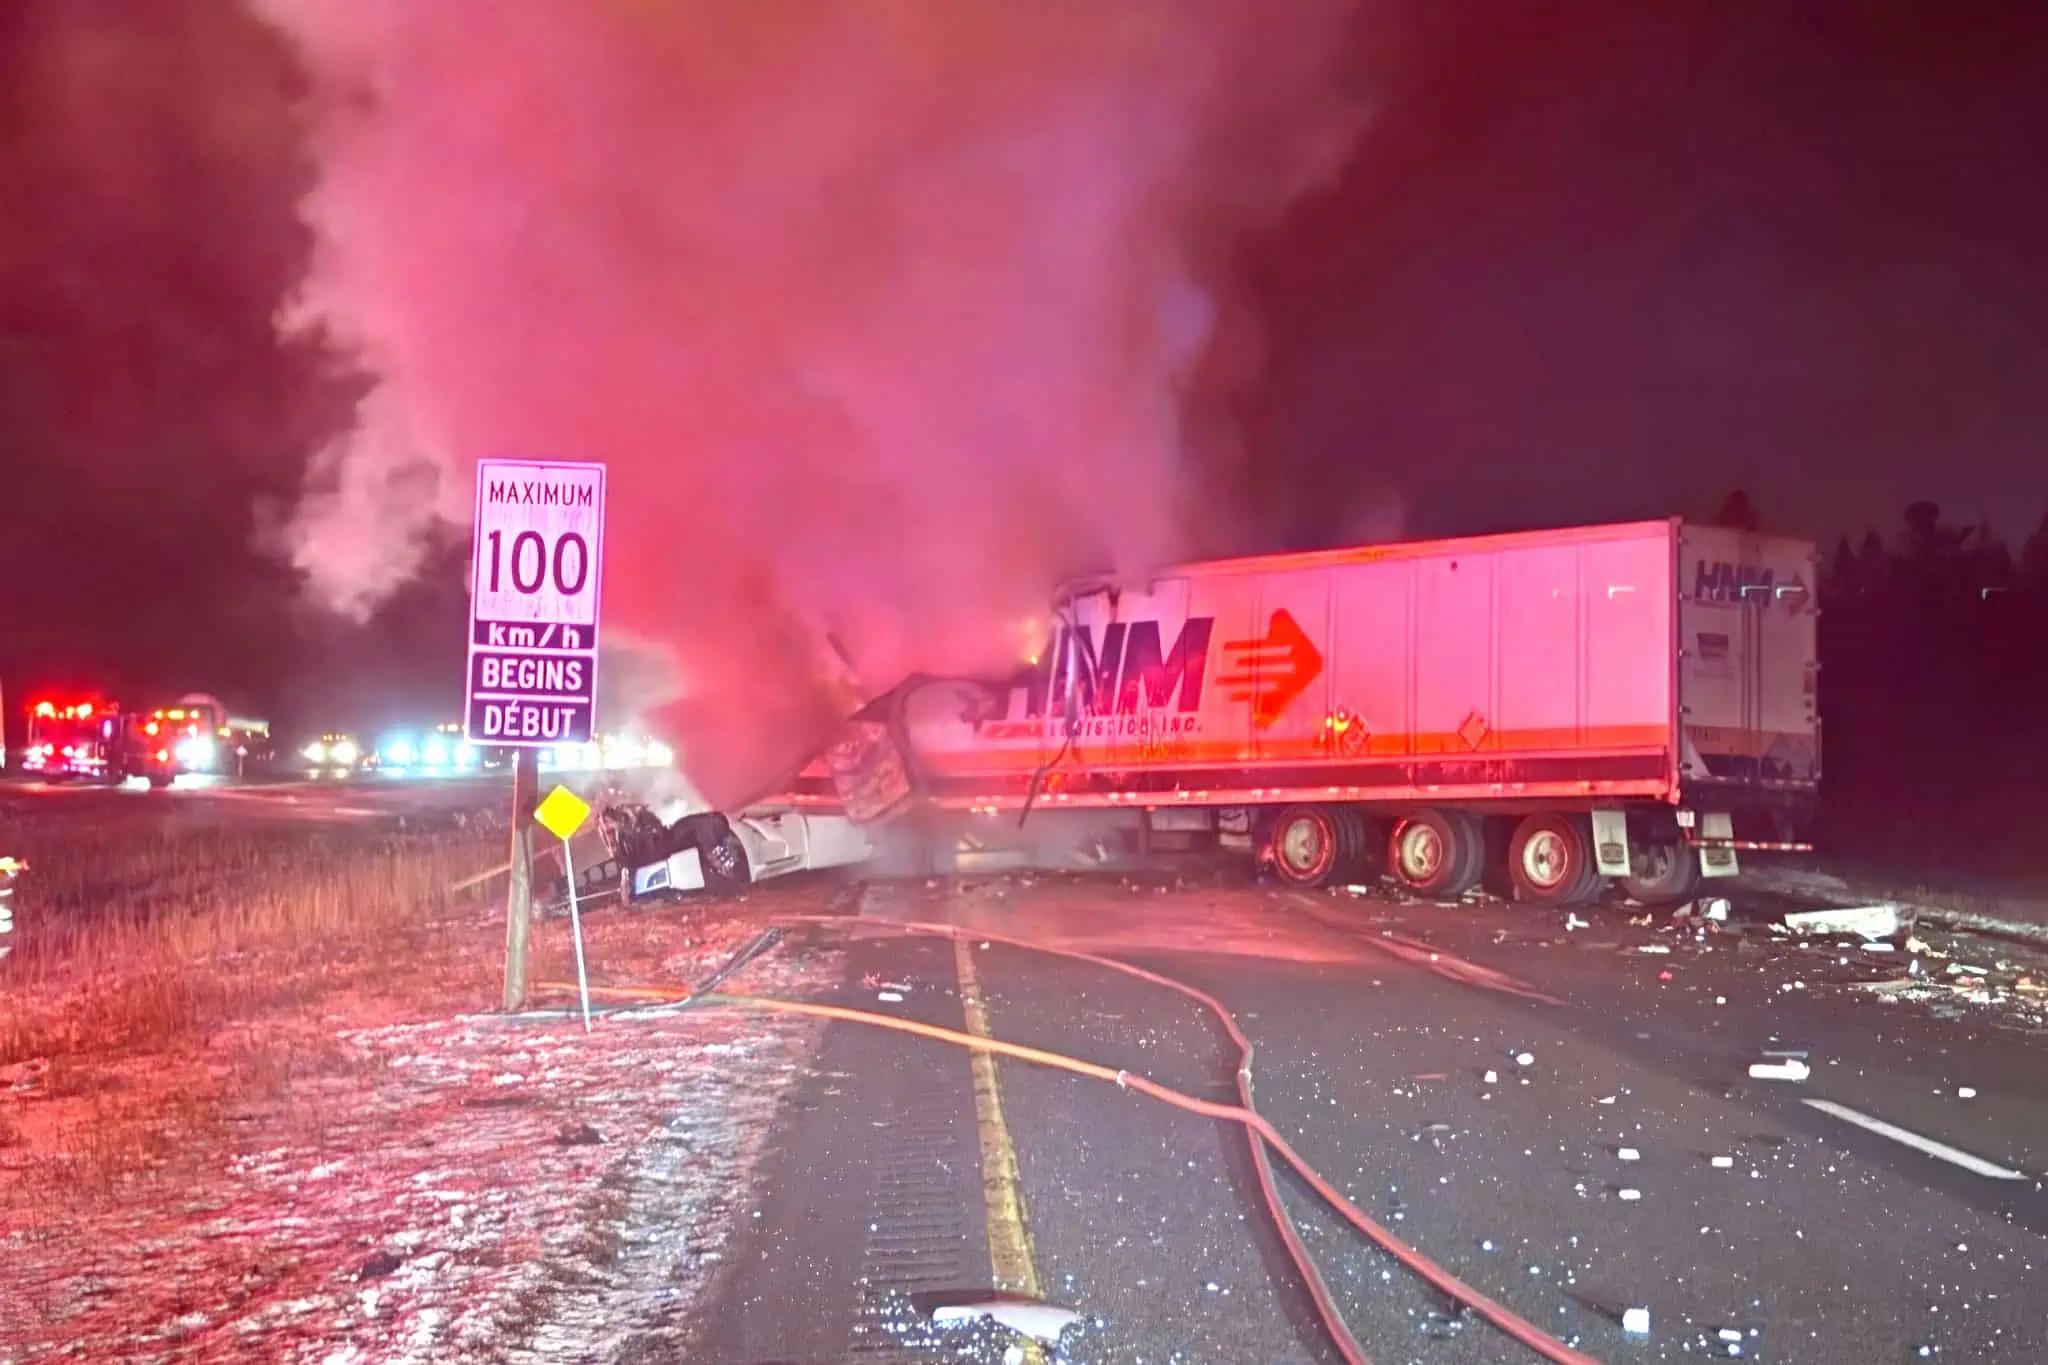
[786,520,1821,905]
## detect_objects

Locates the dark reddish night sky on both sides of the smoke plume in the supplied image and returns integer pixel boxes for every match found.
[0,0,2048,729]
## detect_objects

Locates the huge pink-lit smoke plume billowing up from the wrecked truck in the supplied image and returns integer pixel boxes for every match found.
[262,0,1360,802]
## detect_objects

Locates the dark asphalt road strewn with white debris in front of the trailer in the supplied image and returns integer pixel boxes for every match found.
[698,874,2048,1361]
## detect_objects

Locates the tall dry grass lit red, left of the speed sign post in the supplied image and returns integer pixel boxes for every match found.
[0,829,502,1195]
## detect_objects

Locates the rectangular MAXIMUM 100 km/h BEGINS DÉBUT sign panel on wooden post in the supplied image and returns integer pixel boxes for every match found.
[463,460,604,745]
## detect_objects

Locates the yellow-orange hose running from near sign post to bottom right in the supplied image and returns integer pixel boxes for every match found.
[696,986,1595,1365]
